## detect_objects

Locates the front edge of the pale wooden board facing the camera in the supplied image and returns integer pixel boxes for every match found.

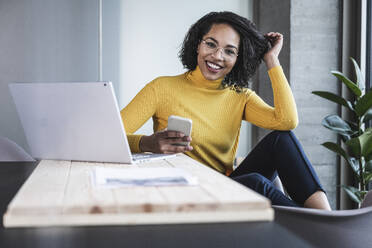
[6,208,274,227]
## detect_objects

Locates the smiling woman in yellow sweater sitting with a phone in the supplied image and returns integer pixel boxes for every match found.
[121,12,330,209]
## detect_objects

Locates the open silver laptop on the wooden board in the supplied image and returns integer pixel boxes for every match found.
[9,82,174,164]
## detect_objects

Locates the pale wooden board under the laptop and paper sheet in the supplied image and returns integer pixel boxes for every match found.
[3,154,274,227]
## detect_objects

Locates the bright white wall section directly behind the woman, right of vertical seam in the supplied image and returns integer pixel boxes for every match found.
[103,0,252,156]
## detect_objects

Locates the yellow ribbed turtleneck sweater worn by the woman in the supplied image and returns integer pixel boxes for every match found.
[121,66,298,173]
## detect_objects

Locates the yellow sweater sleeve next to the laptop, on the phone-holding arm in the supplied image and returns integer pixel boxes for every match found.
[120,83,157,152]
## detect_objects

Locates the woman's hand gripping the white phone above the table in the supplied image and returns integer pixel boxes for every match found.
[139,130,193,154]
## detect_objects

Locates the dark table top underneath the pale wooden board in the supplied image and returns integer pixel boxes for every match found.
[0,162,312,248]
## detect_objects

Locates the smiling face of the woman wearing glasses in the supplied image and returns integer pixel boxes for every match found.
[198,24,240,80]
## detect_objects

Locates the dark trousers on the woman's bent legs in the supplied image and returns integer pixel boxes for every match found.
[230,131,325,206]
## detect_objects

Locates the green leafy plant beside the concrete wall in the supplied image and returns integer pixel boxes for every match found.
[312,58,372,204]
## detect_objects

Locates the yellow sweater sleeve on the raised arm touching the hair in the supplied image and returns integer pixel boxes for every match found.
[244,66,298,130]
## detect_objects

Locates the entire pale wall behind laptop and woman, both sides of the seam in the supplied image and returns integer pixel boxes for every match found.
[0,0,252,156]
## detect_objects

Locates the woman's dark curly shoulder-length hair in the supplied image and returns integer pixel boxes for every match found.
[179,11,269,89]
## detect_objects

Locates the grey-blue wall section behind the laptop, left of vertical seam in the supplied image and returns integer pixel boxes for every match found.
[0,0,98,150]
